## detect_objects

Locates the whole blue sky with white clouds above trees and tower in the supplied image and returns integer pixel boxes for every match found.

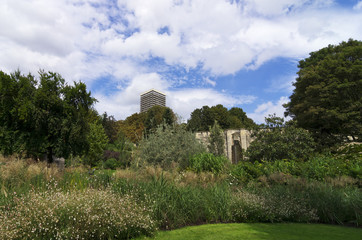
[0,0,362,123]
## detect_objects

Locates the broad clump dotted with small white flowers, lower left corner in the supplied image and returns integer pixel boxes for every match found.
[0,189,156,239]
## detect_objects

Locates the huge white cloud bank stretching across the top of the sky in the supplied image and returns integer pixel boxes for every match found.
[0,0,362,79]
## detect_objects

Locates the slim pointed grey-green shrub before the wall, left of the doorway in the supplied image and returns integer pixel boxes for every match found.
[207,121,225,156]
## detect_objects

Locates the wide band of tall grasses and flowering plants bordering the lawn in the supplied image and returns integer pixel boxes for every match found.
[0,153,362,239]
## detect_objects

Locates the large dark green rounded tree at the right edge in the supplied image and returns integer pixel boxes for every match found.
[285,39,362,146]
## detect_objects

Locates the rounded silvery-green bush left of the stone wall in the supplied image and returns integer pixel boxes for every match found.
[136,125,205,169]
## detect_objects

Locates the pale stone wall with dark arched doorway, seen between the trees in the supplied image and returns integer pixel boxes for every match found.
[196,129,253,163]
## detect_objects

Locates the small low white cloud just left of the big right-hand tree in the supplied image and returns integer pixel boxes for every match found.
[247,96,289,123]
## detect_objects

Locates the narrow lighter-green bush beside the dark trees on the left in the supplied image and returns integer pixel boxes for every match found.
[84,123,108,166]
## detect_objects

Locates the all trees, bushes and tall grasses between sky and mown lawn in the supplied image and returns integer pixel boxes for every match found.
[0,40,362,239]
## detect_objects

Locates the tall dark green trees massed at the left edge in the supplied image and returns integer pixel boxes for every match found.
[0,71,96,162]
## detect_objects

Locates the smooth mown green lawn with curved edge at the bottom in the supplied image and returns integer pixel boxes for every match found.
[139,223,362,240]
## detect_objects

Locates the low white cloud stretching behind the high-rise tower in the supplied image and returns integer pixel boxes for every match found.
[95,77,256,120]
